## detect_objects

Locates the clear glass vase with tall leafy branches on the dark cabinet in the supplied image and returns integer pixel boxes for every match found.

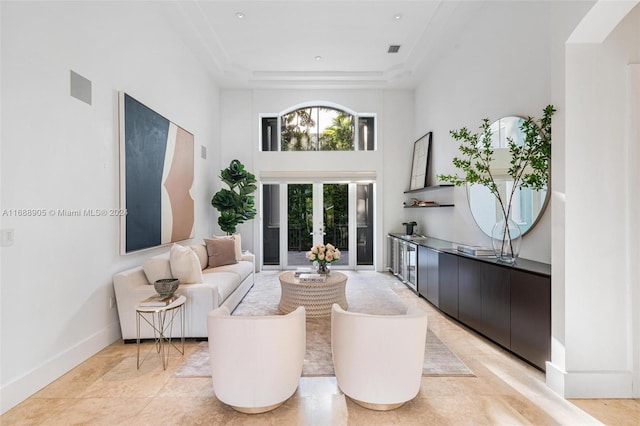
[438,105,556,263]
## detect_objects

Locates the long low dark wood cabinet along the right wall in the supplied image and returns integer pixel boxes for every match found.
[390,238,551,371]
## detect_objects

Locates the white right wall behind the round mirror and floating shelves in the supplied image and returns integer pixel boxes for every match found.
[410,2,585,263]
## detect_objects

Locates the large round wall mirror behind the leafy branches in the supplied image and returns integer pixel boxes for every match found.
[467,117,548,236]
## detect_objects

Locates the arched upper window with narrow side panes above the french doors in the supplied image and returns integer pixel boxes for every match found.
[261,103,376,151]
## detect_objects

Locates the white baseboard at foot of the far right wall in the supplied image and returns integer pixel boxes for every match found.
[546,362,633,398]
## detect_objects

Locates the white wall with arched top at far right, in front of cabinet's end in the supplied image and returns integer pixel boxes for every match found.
[547,1,640,398]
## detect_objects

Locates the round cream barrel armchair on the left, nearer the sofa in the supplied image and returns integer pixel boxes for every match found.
[207,307,306,414]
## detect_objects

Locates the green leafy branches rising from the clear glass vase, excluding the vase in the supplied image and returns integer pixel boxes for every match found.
[438,105,556,256]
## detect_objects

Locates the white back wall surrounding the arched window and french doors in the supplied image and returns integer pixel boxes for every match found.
[221,89,414,270]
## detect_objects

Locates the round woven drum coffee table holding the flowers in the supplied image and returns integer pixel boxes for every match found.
[278,271,349,317]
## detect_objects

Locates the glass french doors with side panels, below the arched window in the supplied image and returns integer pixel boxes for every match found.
[262,183,374,269]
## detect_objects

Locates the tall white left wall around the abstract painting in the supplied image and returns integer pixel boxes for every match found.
[0,1,220,412]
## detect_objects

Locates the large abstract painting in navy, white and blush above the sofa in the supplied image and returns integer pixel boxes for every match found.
[119,92,194,253]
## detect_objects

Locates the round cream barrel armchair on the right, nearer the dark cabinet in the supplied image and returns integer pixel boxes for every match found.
[331,304,427,411]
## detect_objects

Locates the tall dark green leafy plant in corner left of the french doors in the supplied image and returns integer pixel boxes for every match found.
[211,160,257,235]
